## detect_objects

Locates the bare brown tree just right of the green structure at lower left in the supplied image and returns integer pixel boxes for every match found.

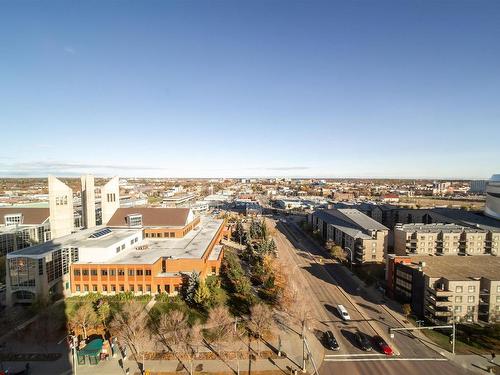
[110,301,151,373]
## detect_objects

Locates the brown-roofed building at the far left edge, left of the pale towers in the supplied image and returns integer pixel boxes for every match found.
[0,207,50,255]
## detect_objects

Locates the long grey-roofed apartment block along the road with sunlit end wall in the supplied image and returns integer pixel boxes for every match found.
[308,209,389,264]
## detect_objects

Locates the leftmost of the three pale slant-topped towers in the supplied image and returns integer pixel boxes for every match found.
[49,176,75,239]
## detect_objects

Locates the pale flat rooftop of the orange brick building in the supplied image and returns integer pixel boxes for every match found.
[78,216,224,264]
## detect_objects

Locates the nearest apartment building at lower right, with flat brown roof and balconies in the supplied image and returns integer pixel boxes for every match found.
[386,255,500,324]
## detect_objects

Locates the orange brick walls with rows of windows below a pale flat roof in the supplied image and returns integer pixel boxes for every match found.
[70,219,229,294]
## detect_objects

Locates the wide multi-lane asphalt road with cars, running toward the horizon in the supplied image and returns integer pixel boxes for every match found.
[268,219,467,374]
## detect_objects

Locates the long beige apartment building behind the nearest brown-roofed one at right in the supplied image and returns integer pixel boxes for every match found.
[394,224,500,255]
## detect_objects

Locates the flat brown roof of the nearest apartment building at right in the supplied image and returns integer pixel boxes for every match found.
[402,255,500,280]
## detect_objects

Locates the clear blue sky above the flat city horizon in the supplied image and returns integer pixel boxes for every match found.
[0,0,500,178]
